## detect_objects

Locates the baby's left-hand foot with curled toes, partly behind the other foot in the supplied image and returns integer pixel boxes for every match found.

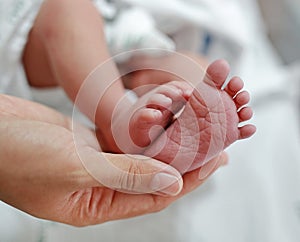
[112,81,193,154]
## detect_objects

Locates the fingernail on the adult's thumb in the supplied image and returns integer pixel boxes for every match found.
[151,173,183,196]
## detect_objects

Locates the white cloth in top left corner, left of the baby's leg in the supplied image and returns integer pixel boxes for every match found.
[0,0,42,98]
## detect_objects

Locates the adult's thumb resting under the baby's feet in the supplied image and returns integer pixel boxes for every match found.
[81,150,183,196]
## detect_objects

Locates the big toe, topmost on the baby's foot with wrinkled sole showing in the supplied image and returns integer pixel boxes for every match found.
[204,60,230,88]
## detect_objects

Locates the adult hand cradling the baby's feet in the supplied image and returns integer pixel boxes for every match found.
[0,95,227,226]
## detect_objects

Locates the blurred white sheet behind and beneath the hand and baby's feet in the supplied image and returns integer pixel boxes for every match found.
[0,0,300,242]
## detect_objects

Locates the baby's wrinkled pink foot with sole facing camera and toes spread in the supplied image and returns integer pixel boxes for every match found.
[144,60,256,173]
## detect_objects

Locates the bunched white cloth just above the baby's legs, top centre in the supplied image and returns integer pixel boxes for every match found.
[97,7,175,63]
